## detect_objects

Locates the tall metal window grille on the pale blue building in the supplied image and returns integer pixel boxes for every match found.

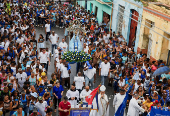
[117,5,125,34]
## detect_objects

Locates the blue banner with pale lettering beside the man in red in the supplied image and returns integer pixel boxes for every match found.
[70,108,90,116]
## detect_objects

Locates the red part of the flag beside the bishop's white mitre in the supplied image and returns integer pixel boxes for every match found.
[85,85,100,105]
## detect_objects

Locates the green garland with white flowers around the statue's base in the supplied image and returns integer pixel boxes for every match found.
[62,51,92,63]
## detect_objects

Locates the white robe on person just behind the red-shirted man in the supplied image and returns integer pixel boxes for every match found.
[66,90,79,108]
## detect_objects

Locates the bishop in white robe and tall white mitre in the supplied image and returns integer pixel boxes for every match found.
[93,85,109,116]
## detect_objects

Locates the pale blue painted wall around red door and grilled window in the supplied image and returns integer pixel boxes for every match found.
[112,0,143,51]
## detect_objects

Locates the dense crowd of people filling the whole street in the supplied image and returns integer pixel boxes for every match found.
[0,0,170,116]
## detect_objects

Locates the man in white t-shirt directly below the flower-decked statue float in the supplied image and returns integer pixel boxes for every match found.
[74,72,85,93]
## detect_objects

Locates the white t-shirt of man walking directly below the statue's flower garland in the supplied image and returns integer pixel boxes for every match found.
[74,76,85,90]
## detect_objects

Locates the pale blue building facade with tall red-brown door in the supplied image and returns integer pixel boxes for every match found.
[112,0,143,51]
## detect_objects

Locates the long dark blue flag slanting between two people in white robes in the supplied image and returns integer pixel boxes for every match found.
[115,84,133,116]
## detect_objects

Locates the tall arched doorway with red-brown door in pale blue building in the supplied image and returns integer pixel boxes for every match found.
[128,9,139,47]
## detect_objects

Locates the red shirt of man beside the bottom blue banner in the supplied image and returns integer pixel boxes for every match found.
[59,101,71,116]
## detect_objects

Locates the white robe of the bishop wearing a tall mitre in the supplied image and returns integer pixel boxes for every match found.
[90,94,109,116]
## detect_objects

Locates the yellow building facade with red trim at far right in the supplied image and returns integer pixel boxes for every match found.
[137,0,170,65]
